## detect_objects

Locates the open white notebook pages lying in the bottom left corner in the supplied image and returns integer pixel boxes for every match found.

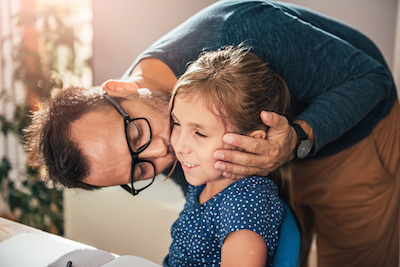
[0,233,160,267]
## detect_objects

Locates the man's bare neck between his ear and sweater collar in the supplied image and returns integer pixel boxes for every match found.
[129,58,177,94]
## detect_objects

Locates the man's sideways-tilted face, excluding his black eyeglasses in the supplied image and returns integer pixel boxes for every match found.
[70,90,175,186]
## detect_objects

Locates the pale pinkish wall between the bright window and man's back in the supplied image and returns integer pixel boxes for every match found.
[93,0,216,85]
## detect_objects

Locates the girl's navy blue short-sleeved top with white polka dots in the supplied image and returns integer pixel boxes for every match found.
[163,176,283,266]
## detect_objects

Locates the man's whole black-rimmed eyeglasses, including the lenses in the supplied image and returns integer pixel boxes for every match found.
[104,93,156,196]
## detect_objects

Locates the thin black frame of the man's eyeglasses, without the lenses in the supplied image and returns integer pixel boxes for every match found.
[103,92,156,196]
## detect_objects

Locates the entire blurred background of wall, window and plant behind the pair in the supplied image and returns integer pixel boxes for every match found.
[0,0,400,263]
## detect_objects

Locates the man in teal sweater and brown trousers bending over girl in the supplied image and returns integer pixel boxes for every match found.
[25,0,400,266]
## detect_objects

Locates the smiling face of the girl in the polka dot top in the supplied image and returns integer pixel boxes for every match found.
[171,95,230,185]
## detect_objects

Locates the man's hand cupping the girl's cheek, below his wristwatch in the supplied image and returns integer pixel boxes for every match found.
[214,111,297,179]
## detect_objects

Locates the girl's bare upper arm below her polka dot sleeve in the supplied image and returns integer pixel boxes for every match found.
[221,230,268,267]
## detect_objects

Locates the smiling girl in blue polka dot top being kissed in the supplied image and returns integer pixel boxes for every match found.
[163,46,290,266]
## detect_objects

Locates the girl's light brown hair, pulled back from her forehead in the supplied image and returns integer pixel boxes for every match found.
[170,44,290,199]
